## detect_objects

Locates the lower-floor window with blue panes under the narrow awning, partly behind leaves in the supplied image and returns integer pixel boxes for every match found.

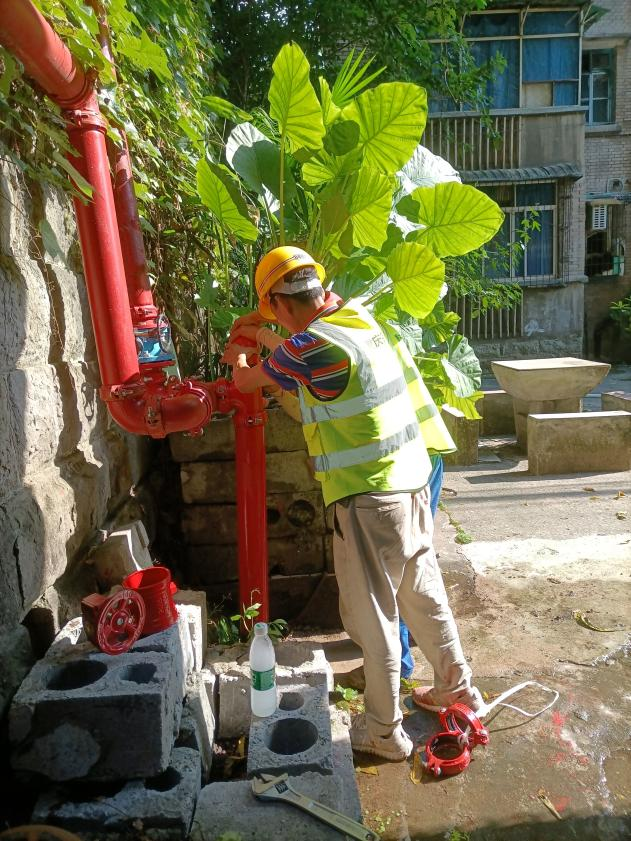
[480,181,556,285]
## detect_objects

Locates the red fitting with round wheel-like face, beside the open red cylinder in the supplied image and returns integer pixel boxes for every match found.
[81,590,146,654]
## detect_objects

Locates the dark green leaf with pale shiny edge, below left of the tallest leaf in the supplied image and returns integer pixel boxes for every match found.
[226,123,296,203]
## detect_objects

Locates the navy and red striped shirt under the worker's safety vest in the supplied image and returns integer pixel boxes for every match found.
[263,302,350,400]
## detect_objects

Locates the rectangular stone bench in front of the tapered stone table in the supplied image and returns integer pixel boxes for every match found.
[528,411,631,476]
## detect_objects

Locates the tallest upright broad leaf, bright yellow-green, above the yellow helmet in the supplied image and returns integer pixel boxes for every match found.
[269,43,324,150]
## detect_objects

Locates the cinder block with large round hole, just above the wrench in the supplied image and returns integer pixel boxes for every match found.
[247,683,333,777]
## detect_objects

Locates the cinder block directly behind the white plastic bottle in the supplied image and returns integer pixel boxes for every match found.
[206,641,333,739]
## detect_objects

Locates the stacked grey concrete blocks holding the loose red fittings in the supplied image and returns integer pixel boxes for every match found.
[9,593,215,841]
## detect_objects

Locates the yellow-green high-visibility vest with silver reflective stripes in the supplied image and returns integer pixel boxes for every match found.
[299,301,456,505]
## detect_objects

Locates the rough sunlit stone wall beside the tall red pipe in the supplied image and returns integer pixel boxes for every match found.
[0,162,152,676]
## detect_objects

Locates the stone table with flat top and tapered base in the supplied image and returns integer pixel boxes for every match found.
[491,356,611,449]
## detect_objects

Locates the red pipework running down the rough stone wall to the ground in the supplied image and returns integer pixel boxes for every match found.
[0,0,269,619]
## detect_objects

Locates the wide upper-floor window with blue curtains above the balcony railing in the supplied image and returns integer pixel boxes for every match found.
[430,9,580,113]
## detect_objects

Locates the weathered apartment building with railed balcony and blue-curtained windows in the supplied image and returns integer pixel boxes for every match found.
[425,0,631,361]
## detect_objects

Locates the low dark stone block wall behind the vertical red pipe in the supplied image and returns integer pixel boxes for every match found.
[170,408,339,627]
